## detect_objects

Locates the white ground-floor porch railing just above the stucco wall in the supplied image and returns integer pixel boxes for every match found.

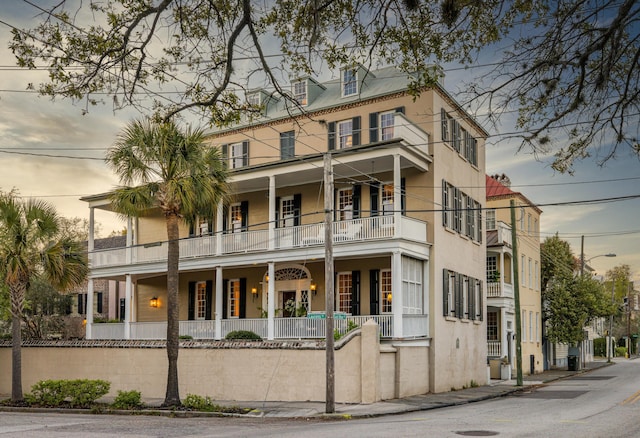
[91,315,429,340]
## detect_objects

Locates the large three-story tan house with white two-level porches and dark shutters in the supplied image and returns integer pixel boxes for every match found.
[83,67,488,396]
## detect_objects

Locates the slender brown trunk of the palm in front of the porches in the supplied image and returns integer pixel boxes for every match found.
[163,213,181,406]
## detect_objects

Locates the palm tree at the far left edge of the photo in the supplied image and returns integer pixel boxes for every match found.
[0,194,88,402]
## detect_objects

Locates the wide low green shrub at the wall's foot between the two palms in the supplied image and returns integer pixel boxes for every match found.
[25,379,111,407]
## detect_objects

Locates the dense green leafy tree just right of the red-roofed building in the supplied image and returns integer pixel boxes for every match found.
[540,235,613,343]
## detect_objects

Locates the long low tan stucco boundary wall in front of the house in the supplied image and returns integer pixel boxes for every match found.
[0,327,429,403]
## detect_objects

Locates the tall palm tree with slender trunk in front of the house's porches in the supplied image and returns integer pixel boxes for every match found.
[106,120,228,406]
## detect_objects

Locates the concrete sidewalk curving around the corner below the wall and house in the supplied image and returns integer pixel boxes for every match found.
[217,360,609,418]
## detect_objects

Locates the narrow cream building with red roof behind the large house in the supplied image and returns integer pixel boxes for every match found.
[486,174,546,374]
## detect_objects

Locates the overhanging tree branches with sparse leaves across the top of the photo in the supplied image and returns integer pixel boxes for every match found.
[10,0,640,172]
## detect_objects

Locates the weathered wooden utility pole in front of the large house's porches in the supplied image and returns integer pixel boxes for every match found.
[324,152,335,414]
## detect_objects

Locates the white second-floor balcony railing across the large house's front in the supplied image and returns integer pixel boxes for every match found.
[89,216,427,269]
